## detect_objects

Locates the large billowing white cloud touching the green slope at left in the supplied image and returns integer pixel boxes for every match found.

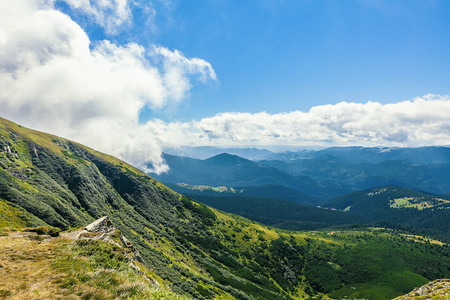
[0,0,215,171]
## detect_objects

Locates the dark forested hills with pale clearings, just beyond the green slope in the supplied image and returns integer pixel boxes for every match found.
[170,184,450,241]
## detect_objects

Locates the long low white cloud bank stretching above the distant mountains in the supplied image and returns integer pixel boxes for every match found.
[147,95,450,150]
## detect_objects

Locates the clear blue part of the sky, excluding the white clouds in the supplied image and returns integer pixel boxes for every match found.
[59,0,450,121]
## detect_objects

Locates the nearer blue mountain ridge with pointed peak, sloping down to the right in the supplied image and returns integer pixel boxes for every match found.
[151,153,352,198]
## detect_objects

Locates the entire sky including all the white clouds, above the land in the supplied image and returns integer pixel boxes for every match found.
[0,0,450,172]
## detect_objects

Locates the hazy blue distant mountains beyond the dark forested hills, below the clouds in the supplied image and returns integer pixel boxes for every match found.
[152,147,450,199]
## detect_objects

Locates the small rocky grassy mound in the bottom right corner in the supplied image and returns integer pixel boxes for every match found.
[395,279,450,300]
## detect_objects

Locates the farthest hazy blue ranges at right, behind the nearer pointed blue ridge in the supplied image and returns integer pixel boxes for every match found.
[259,147,450,196]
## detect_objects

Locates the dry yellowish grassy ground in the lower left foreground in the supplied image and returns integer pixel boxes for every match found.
[0,236,187,300]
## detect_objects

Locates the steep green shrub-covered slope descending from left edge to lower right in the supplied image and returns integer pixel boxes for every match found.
[0,119,450,299]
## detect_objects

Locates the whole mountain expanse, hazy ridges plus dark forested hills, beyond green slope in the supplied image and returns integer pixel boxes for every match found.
[150,147,450,240]
